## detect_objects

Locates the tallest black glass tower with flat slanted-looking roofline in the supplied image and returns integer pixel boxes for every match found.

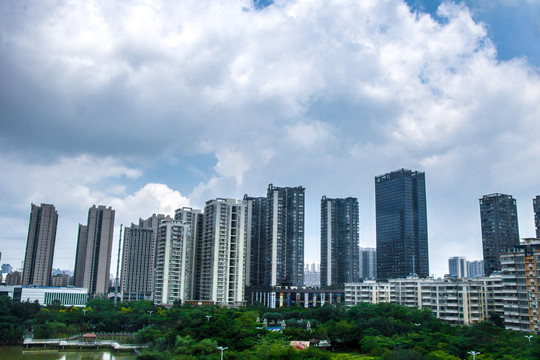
[375,169,429,279]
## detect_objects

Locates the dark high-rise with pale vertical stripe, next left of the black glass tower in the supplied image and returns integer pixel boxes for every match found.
[321,196,359,287]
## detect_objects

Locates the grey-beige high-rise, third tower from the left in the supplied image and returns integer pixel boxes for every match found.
[120,214,172,301]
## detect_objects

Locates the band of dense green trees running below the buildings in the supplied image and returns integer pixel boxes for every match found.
[0,296,540,360]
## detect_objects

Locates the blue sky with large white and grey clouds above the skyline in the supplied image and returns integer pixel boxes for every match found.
[0,0,540,276]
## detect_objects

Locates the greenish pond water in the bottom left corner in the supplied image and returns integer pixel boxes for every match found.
[0,346,137,360]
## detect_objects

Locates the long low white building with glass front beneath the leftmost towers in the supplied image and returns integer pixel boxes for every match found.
[0,286,88,307]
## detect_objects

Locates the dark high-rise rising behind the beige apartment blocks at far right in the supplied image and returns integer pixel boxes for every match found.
[479,194,519,276]
